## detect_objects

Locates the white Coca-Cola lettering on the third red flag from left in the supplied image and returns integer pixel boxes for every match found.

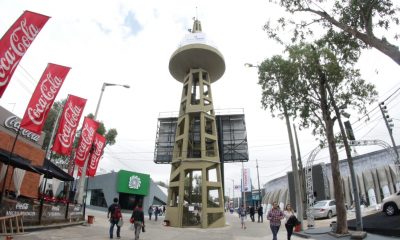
[57,102,83,148]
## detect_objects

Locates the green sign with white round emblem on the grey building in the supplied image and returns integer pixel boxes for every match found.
[117,170,150,196]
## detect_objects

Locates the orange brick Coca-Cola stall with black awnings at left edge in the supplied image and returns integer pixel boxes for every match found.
[0,107,79,229]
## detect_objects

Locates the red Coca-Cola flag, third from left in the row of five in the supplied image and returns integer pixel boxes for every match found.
[52,95,86,155]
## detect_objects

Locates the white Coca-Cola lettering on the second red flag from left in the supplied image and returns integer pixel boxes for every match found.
[28,73,63,126]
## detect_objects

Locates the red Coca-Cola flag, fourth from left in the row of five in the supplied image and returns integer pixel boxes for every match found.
[75,117,99,167]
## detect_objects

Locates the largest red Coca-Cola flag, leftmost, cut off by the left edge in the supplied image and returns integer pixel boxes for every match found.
[0,11,50,98]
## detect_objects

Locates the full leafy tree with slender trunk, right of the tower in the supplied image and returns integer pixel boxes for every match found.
[259,42,377,234]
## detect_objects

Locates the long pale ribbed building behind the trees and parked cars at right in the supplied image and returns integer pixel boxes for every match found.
[263,146,400,212]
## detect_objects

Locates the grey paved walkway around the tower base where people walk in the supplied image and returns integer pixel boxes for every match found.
[10,209,395,240]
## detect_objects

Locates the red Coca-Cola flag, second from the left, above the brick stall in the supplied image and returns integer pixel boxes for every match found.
[21,63,70,135]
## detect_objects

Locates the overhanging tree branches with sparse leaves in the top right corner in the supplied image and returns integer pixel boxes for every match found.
[264,0,400,65]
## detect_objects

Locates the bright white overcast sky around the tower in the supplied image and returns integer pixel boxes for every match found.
[0,0,400,197]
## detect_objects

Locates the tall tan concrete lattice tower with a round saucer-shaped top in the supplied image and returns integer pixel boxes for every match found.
[165,19,225,228]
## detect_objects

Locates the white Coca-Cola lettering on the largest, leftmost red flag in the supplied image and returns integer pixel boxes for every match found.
[0,18,40,87]
